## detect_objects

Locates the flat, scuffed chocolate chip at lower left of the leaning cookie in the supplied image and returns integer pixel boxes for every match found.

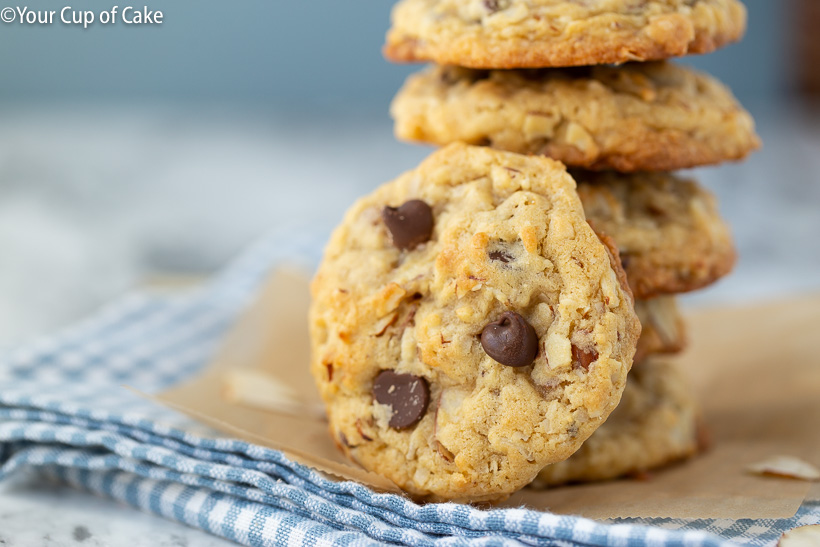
[373,370,430,429]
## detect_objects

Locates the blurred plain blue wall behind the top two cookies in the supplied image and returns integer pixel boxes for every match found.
[0,0,791,106]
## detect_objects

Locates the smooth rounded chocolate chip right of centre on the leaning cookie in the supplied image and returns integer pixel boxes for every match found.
[481,311,538,367]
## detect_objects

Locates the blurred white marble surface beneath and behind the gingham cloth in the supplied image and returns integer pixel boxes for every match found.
[0,101,820,547]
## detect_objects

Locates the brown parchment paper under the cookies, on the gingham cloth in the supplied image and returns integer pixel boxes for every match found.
[158,271,820,519]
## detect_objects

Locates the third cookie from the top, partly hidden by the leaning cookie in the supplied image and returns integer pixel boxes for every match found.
[573,171,736,299]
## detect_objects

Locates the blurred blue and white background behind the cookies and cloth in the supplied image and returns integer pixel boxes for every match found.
[0,0,820,349]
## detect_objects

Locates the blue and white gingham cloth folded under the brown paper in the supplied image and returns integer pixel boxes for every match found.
[0,229,820,547]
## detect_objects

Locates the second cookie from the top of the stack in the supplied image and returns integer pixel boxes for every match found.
[391,62,760,172]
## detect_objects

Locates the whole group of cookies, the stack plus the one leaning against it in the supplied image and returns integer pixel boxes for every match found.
[310,0,758,502]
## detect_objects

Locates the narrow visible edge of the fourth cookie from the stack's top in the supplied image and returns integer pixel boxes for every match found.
[635,296,686,363]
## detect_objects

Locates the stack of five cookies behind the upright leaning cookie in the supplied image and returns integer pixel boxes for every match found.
[385,0,759,485]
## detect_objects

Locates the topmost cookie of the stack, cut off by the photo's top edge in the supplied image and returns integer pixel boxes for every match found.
[384,0,746,68]
